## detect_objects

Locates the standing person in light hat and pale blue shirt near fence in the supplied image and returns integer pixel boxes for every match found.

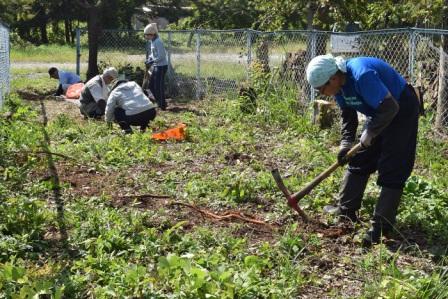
[144,23,168,110]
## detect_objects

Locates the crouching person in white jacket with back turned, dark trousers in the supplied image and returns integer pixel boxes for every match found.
[105,80,157,134]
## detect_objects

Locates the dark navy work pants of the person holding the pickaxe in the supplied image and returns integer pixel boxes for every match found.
[348,86,419,189]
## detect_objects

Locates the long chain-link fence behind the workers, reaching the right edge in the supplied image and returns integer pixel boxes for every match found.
[77,28,448,131]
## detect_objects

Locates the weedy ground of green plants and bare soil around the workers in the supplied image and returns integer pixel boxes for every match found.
[0,55,448,299]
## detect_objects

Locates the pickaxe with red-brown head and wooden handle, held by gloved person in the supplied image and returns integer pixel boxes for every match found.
[271,143,362,222]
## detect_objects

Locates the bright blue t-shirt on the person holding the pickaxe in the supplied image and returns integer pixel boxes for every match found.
[335,57,406,116]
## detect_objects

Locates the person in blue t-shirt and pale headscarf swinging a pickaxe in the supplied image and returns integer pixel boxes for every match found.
[306,54,420,246]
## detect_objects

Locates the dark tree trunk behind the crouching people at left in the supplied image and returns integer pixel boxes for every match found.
[86,6,102,80]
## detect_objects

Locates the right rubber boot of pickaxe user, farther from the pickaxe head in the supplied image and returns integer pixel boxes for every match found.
[363,187,403,247]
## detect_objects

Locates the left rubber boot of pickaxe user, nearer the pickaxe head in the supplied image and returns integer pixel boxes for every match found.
[324,171,369,222]
